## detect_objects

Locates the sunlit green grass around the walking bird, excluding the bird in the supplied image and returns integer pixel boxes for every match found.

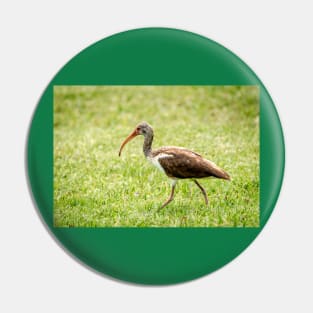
[54,86,259,227]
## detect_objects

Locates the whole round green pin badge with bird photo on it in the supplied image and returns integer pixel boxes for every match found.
[27,28,285,285]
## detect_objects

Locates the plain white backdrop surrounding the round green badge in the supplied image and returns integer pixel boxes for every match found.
[0,0,313,312]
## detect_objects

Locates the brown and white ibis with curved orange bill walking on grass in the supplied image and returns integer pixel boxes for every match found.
[118,122,230,210]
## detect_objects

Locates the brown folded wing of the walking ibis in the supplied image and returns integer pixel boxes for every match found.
[153,147,230,179]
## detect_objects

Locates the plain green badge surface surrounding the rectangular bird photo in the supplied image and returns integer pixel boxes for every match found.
[27,28,285,285]
